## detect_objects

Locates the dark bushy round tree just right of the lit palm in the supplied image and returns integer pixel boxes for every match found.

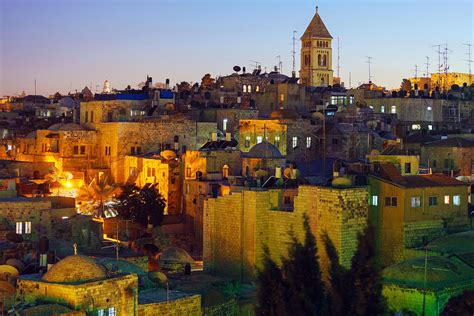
[116,184,165,226]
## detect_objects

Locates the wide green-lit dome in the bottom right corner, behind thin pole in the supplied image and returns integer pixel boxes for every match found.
[383,256,474,289]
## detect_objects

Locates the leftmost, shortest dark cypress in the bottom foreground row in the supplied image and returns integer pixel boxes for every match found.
[256,246,285,315]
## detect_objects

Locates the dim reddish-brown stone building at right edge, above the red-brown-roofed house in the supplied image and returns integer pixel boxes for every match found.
[421,137,474,177]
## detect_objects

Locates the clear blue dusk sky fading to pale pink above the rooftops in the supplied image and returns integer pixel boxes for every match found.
[0,0,474,95]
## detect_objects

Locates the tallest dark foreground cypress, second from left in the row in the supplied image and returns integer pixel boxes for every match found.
[282,214,326,315]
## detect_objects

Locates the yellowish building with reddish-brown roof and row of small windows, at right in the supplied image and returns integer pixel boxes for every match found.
[369,164,469,266]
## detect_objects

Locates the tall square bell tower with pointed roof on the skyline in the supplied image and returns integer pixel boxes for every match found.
[300,7,333,87]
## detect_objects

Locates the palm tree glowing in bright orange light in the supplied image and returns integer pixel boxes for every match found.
[76,177,116,218]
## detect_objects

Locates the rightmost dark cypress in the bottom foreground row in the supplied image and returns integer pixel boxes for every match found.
[348,223,386,316]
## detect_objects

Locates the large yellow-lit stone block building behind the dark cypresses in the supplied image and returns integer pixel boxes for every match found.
[203,186,368,281]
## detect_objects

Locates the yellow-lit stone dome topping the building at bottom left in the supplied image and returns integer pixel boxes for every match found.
[42,255,107,283]
